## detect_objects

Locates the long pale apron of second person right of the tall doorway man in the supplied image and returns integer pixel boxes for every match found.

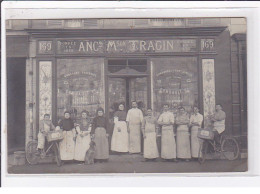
[161,125,176,159]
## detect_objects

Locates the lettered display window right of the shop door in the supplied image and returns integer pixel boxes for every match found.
[151,57,198,114]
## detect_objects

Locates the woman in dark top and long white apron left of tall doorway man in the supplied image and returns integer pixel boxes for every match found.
[111,103,129,152]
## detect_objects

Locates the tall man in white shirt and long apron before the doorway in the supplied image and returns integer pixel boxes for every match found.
[126,101,143,154]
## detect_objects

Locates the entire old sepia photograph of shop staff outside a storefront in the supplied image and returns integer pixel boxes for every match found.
[5,14,248,175]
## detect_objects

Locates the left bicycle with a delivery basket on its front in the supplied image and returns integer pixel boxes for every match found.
[26,130,63,166]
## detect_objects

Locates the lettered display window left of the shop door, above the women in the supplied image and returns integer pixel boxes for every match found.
[57,59,104,120]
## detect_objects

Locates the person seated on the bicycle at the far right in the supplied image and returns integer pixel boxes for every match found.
[211,104,226,144]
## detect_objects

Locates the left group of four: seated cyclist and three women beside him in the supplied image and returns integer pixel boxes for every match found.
[37,108,109,162]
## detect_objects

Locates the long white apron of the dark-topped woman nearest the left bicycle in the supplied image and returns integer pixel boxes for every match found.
[60,130,75,160]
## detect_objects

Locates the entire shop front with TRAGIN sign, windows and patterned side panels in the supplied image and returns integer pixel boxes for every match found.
[26,27,231,145]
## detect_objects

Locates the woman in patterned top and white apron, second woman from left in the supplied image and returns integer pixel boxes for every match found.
[74,110,91,161]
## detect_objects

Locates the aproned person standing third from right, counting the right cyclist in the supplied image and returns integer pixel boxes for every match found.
[176,107,191,161]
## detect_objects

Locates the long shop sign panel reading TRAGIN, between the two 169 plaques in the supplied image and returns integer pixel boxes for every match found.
[56,39,197,54]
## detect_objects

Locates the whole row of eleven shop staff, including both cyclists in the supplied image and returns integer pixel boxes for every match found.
[38,101,226,162]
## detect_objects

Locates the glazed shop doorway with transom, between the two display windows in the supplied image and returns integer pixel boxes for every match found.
[107,59,150,114]
